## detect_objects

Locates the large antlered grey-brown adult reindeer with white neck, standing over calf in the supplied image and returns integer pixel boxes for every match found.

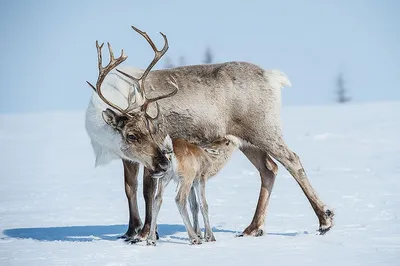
[86,26,333,239]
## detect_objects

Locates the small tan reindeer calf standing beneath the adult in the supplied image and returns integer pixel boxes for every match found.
[147,136,239,245]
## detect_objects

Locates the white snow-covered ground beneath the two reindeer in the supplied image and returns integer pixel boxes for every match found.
[0,102,400,266]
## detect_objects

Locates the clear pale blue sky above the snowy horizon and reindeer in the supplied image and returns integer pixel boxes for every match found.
[0,0,400,113]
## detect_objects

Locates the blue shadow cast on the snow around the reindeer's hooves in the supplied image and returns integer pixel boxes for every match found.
[3,224,307,242]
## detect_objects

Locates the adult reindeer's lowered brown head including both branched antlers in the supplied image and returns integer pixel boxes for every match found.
[87,26,178,172]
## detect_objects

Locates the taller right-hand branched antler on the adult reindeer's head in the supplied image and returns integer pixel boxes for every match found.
[116,26,178,127]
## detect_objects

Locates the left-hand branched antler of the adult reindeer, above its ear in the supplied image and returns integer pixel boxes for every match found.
[86,41,128,114]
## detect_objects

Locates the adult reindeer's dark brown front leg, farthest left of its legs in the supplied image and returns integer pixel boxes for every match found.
[121,160,142,239]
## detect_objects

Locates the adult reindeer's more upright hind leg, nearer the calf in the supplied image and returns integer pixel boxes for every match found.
[239,146,278,236]
